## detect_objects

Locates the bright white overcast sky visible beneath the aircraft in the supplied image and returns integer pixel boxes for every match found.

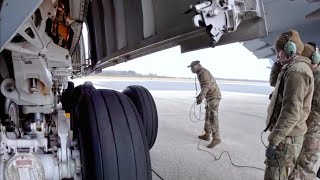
[83,25,270,80]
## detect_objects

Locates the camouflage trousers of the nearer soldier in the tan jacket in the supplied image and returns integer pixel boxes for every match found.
[264,136,303,180]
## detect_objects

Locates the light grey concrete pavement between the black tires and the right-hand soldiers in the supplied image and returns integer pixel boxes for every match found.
[150,91,268,180]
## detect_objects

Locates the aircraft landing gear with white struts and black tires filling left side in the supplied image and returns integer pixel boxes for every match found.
[0,0,157,180]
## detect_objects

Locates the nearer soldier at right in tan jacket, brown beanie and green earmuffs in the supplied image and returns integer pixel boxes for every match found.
[264,30,314,180]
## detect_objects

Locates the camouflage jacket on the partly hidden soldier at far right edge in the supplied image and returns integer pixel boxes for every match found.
[305,67,320,138]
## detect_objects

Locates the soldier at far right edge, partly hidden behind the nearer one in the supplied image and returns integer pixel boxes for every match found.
[289,43,320,180]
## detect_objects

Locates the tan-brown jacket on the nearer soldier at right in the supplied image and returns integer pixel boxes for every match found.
[266,56,314,146]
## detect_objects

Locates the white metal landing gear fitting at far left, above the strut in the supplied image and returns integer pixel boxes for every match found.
[1,52,53,105]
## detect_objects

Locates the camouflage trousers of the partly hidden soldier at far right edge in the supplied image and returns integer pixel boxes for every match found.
[289,137,320,180]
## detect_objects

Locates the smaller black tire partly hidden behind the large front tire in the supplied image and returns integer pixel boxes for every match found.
[122,85,158,149]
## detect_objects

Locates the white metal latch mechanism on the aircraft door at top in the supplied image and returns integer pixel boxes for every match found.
[191,0,260,44]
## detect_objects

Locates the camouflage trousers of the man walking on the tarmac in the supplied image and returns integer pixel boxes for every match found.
[204,99,220,139]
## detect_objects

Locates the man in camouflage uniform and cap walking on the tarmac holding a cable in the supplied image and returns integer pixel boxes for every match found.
[188,61,221,148]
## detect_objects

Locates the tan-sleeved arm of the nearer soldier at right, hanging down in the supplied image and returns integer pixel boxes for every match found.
[268,72,313,146]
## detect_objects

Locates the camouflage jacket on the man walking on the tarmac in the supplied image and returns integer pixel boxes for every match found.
[197,67,221,101]
